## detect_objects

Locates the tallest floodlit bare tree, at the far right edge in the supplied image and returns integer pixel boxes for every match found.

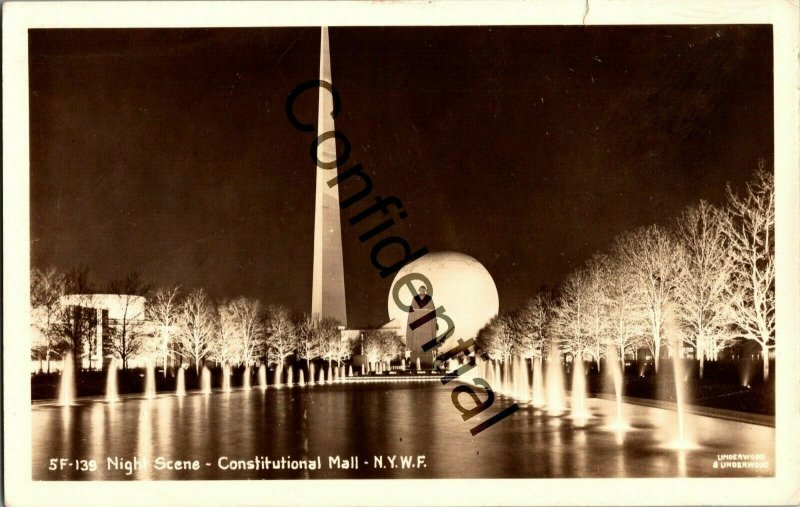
[724,169,775,379]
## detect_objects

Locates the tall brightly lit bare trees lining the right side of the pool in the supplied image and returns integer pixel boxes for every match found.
[477,167,775,378]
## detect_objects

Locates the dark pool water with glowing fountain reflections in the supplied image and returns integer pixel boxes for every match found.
[32,382,774,480]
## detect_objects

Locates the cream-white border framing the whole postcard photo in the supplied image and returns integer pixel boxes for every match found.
[3,0,800,506]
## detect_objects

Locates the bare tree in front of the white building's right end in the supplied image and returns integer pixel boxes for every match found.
[108,272,150,370]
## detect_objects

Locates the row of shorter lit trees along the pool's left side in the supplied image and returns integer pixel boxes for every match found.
[31,269,353,374]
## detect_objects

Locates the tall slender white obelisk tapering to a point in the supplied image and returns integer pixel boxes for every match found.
[311,26,347,326]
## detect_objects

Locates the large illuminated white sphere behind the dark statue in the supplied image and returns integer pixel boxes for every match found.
[389,252,500,350]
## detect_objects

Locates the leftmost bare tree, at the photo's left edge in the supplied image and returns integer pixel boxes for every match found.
[31,268,66,373]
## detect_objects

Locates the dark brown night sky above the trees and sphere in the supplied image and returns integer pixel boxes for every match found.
[29,25,773,326]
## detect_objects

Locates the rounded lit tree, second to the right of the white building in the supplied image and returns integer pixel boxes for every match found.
[177,289,214,373]
